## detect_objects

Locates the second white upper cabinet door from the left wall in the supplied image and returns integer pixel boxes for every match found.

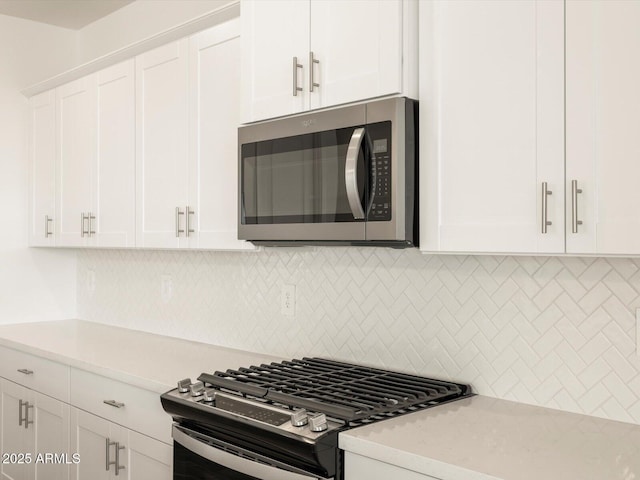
[56,74,96,246]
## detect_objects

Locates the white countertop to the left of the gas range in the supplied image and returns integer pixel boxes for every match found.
[0,320,282,393]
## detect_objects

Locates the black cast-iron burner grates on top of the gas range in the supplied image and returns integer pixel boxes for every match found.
[198,358,471,422]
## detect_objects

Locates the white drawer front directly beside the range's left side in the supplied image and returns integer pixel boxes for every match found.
[70,368,172,444]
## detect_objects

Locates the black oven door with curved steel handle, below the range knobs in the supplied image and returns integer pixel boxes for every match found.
[173,425,333,480]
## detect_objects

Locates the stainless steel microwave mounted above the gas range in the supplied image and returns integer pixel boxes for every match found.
[238,97,418,248]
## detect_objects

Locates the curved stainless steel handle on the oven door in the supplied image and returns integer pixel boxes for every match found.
[173,425,329,480]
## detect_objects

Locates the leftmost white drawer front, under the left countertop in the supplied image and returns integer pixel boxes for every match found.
[0,347,69,402]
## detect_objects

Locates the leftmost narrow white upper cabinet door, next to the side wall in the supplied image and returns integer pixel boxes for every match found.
[29,90,56,247]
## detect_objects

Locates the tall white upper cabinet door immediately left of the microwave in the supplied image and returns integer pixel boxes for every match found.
[189,19,254,250]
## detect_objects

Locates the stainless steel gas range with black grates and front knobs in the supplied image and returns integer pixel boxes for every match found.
[161,358,472,480]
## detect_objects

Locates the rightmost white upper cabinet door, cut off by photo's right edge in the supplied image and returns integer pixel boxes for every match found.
[566,0,640,254]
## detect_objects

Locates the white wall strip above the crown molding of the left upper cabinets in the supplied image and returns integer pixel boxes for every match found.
[78,0,234,63]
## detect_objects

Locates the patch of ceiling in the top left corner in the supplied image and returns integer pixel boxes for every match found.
[0,0,134,30]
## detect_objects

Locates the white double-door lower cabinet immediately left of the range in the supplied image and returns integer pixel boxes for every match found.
[71,408,173,480]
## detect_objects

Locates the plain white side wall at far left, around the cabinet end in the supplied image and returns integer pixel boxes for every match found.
[0,15,76,323]
